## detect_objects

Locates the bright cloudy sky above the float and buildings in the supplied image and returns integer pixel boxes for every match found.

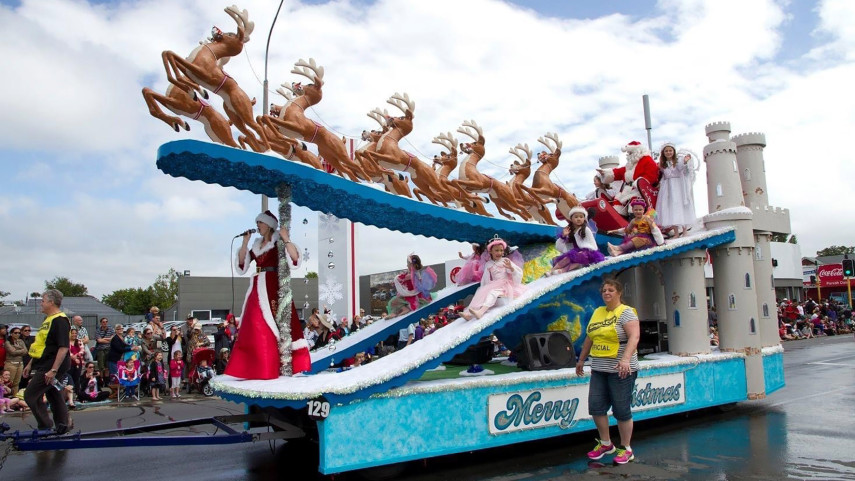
[0,0,855,300]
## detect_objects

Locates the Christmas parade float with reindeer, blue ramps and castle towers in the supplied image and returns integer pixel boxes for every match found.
[1,7,789,474]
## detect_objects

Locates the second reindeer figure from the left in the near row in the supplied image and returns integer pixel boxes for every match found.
[261,58,369,182]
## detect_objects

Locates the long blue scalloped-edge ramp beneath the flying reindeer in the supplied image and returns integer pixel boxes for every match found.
[157,140,555,245]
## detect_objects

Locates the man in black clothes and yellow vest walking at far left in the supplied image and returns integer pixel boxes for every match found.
[24,289,71,434]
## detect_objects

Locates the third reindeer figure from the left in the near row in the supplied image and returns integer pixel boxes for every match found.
[362,92,454,206]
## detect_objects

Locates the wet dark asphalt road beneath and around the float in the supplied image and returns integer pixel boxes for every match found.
[0,335,855,481]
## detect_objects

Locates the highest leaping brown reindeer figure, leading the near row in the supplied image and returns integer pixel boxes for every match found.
[161,5,270,152]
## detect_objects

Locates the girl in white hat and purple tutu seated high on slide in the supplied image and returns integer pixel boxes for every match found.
[547,205,606,275]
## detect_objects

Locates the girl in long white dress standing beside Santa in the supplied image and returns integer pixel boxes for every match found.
[656,143,698,237]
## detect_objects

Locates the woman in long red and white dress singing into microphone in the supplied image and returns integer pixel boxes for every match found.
[225,210,311,379]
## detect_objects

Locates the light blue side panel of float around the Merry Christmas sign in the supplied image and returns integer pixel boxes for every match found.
[319,359,747,474]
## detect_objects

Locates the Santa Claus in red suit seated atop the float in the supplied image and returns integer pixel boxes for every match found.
[597,140,659,216]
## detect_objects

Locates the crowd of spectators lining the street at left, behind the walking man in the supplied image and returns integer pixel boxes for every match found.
[0,307,238,413]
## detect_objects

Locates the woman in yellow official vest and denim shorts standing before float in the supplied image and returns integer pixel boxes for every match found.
[576,279,641,464]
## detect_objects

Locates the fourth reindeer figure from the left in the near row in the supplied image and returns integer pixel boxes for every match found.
[451,120,531,220]
